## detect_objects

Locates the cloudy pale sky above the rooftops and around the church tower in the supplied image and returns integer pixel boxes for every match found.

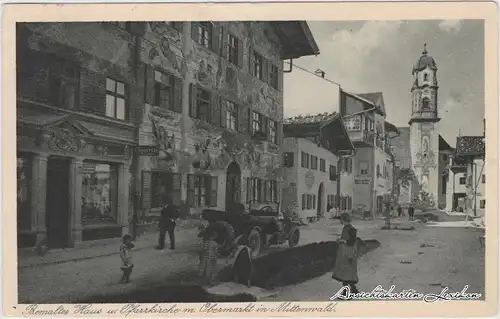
[284,20,484,146]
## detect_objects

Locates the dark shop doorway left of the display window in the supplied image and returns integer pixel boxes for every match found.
[45,158,71,248]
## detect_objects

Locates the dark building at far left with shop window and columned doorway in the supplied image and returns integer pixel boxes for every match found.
[17,23,143,247]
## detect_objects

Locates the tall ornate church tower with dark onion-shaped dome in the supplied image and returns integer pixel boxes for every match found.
[408,44,440,206]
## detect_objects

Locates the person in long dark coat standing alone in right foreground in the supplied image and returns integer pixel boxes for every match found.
[332,213,359,293]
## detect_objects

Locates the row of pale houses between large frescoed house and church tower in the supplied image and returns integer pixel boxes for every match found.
[282,87,399,219]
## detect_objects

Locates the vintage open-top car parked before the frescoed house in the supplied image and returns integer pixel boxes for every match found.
[200,206,300,257]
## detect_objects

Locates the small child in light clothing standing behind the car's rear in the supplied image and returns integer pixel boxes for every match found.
[198,229,218,285]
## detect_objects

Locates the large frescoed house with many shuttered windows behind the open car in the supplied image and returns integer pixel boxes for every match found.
[137,21,319,220]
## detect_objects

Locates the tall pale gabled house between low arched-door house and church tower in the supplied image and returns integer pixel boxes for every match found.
[341,91,398,214]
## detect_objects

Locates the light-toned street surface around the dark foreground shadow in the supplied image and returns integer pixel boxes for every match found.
[18,220,484,303]
